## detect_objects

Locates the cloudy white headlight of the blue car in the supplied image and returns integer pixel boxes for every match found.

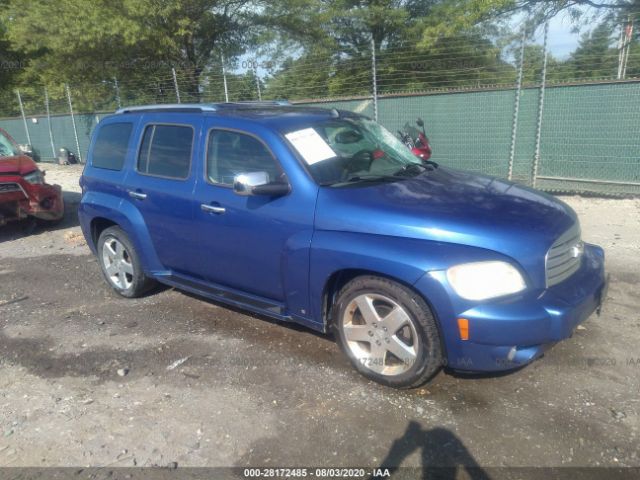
[447,261,526,300]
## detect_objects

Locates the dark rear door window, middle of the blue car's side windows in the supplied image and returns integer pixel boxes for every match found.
[138,125,193,179]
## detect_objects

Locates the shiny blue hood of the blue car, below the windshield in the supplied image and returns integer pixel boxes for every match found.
[316,167,577,284]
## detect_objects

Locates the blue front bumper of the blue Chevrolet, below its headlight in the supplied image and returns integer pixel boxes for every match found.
[416,245,607,372]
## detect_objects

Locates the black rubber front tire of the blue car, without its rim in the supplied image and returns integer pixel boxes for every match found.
[332,275,443,388]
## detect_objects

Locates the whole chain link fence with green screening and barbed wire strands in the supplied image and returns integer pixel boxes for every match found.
[0,22,640,195]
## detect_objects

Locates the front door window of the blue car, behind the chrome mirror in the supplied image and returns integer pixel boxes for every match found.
[207,130,282,185]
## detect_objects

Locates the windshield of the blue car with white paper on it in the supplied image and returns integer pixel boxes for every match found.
[286,118,427,186]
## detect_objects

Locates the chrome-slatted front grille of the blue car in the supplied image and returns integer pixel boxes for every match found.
[546,222,584,288]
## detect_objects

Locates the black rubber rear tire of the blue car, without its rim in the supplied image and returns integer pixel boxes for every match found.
[97,226,156,298]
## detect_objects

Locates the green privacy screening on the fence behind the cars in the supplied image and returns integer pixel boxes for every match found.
[0,81,640,195]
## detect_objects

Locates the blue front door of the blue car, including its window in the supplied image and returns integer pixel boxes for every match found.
[193,124,316,303]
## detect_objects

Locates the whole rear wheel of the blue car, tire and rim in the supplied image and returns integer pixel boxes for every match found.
[98,226,154,298]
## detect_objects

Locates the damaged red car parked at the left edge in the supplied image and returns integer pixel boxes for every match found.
[0,128,64,225]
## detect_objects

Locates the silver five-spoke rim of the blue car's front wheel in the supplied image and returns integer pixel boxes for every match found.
[342,293,420,376]
